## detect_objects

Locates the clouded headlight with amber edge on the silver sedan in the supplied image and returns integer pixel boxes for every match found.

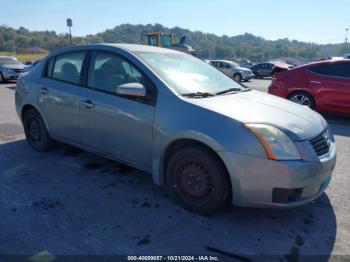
[244,124,301,160]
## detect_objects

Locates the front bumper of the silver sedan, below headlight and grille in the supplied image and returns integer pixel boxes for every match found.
[219,142,336,208]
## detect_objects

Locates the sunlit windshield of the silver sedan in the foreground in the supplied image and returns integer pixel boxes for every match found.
[138,52,244,95]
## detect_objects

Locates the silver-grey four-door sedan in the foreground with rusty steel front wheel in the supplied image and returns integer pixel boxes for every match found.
[15,44,336,214]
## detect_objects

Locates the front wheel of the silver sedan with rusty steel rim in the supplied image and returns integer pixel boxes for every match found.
[166,147,231,215]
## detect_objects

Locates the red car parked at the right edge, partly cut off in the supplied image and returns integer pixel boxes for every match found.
[268,59,350,115]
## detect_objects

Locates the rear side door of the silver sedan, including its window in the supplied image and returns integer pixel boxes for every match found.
[38,51,86,143]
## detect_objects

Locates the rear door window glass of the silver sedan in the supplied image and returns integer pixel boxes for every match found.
[48,51,85,84]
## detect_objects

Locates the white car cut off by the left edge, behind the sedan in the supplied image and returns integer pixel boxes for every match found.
[0,56,26,83]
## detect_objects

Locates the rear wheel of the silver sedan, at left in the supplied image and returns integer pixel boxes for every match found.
[23,109,52,152]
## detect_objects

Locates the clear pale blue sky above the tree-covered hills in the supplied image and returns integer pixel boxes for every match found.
[0,0,350,44]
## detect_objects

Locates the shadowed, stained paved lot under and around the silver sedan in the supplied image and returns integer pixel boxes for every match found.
[0,80,350,261]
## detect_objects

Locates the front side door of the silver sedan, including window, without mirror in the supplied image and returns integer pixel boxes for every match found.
[80,51,156,168]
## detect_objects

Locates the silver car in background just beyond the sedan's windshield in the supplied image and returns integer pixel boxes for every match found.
[209,60,254,81]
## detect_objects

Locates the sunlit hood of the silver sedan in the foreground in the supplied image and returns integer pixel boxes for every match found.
[190,90,327,141]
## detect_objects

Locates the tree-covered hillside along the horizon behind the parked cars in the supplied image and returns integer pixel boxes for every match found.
[0,24,350,62]
